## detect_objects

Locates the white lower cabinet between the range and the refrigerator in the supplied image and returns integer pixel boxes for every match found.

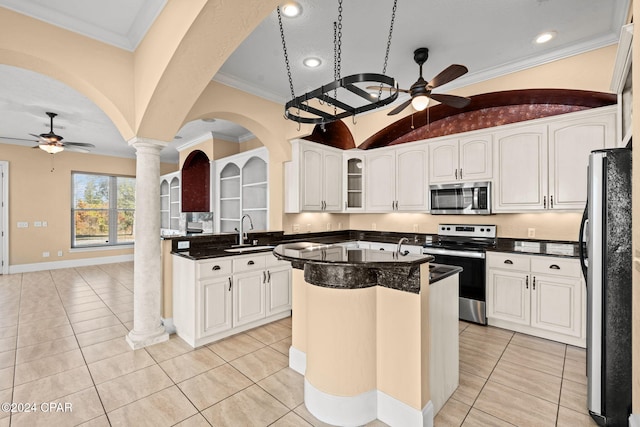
[487,252,586,347]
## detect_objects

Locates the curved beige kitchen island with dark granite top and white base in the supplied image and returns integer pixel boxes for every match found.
[274,242,461,426]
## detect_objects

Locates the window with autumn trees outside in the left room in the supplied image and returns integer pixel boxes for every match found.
[71,172,136,248]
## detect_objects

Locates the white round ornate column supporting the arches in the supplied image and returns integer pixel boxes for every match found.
[127,137,169,349]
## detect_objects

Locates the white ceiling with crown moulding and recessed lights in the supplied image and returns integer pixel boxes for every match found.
[0,0,629,162]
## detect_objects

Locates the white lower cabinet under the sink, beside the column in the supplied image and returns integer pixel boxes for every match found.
[173,253,291,347]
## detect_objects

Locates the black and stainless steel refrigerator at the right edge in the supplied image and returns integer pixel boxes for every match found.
[580,148,632,426]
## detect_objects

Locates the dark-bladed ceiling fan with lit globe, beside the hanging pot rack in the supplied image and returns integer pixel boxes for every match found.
[367,47,471,116]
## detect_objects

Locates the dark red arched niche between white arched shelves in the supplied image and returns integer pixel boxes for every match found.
[182,150,211,212]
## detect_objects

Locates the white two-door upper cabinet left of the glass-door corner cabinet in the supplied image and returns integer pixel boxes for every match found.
[285,140,343,212]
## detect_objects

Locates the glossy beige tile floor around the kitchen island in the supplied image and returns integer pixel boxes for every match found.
[0,263,595,427]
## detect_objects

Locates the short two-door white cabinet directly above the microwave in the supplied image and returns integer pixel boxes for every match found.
[429,133,493,184]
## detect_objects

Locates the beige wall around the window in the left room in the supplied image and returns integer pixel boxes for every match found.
[0,144,136,265]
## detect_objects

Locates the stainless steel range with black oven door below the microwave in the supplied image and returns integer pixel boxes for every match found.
[422,224,496,325]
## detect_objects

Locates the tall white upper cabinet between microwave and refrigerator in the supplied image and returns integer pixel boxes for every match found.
[493,107,616,212]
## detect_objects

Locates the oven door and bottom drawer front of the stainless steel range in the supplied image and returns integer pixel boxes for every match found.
[423,248,487,325]
